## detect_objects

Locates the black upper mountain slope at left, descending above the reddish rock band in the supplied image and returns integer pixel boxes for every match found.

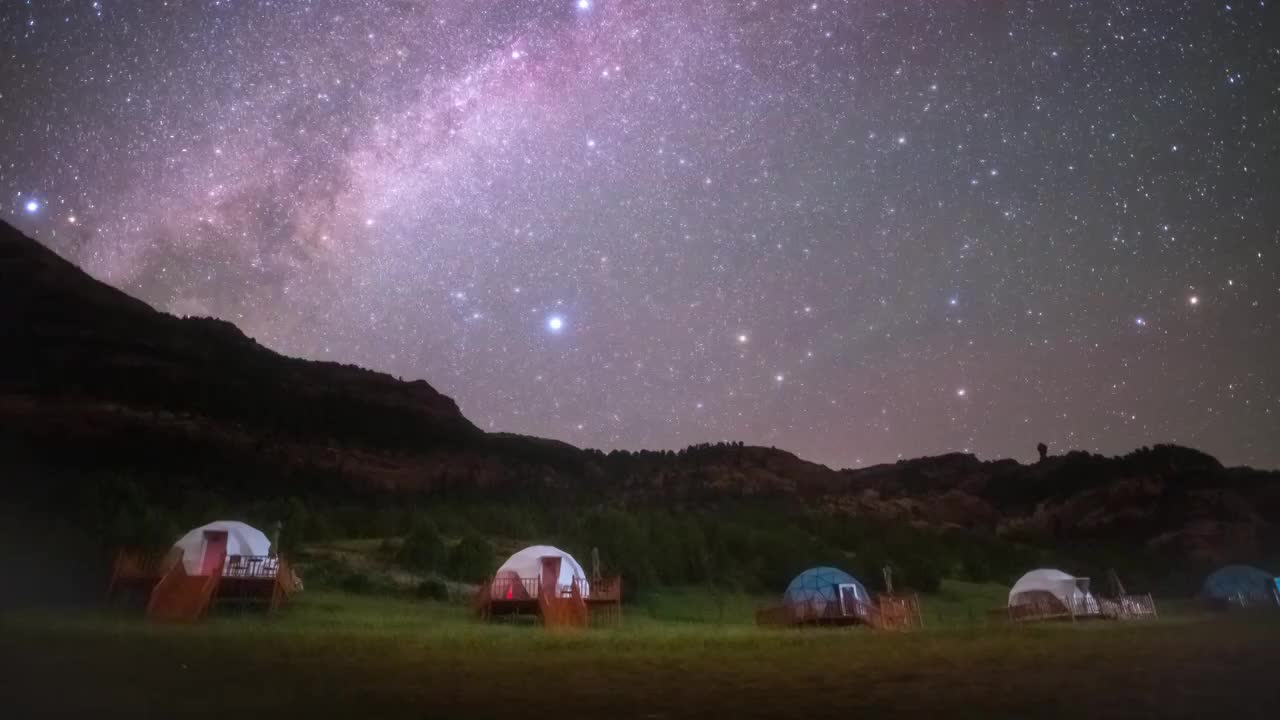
[0,223,479,448]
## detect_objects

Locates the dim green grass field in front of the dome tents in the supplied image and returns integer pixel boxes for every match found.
[0,594,1280,720]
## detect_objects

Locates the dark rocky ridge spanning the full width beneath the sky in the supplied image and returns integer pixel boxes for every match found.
[0,223,1280,561]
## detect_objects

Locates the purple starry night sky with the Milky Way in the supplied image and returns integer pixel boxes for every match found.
[0,0,1280,468]
